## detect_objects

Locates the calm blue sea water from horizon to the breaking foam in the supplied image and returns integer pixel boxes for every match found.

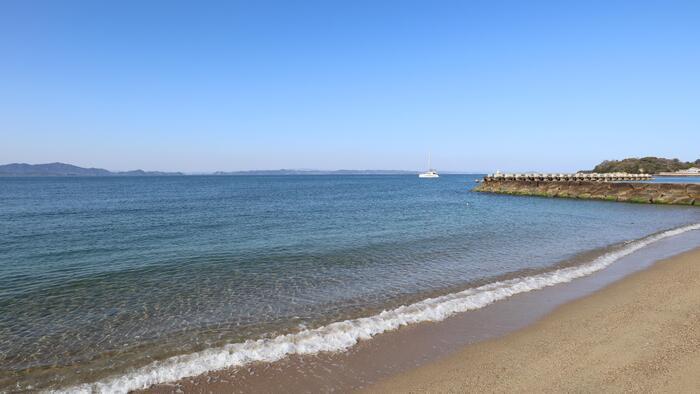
[0,175,700,391]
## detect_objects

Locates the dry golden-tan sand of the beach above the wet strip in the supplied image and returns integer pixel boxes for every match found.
[365,249,700,393]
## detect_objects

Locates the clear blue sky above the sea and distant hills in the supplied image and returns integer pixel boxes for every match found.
[0,0,700,171]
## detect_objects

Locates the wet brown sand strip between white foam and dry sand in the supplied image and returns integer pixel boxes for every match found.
[137,223,700,392]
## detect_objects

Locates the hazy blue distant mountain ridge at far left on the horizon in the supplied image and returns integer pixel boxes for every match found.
[0,163,183,176]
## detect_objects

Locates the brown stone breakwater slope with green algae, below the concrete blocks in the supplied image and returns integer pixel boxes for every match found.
[474,180,700,206]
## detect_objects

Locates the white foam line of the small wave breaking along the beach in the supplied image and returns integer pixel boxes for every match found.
[58,223,700,393]
